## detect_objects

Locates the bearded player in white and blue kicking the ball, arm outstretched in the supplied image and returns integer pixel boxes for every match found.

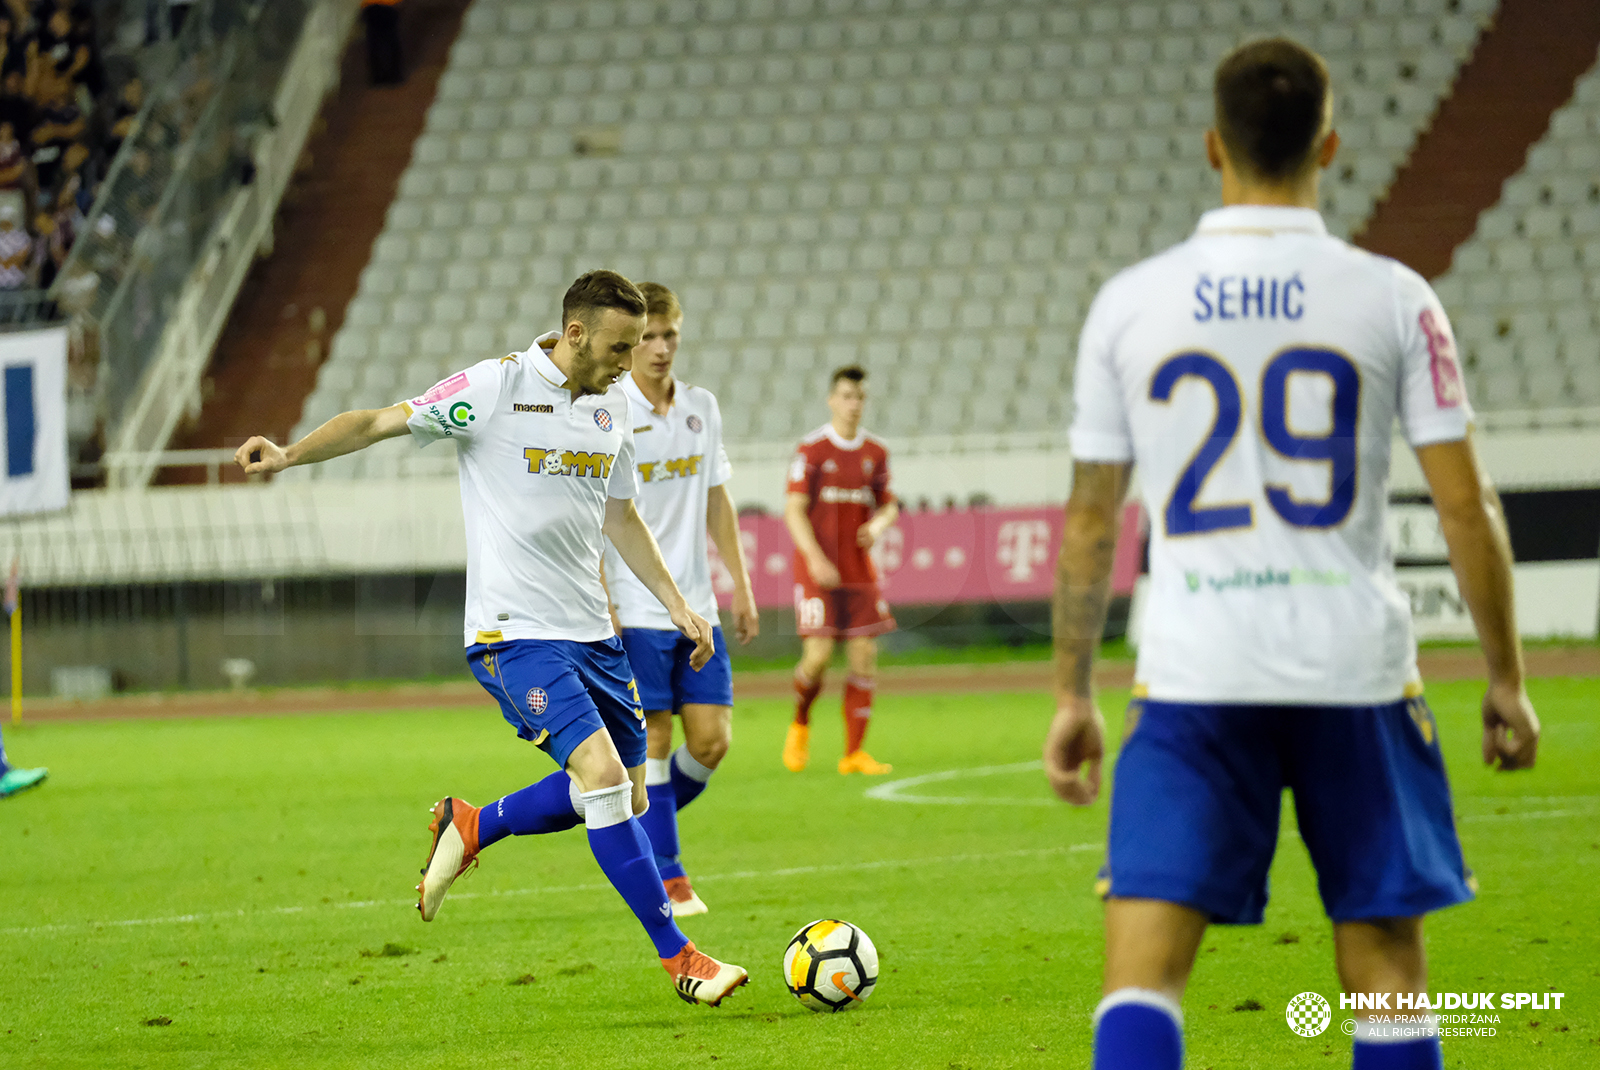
[237,272,747,1006]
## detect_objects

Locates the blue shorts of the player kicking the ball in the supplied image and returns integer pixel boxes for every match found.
[467,637,645,769]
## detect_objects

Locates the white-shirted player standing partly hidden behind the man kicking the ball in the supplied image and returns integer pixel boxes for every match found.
[605,283,762,916]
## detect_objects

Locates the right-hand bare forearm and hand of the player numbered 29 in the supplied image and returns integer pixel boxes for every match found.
[1416,437,1539,769]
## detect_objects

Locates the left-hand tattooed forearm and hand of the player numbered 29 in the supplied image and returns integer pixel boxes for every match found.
[1045,461,1131,806]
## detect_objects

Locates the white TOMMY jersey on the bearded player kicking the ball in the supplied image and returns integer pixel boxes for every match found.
[402,331,635,646]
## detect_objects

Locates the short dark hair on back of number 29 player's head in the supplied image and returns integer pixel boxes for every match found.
[1214,37,1328,181]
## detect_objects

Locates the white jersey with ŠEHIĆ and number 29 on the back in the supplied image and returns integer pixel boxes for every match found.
[1072,206,1472,705]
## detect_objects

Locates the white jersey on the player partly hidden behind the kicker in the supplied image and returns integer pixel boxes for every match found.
[605,374,733,629]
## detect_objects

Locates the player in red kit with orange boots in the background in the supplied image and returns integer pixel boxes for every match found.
[784,365,899,774]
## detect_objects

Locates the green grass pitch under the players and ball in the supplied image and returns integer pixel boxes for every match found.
[0,680,1600,1070]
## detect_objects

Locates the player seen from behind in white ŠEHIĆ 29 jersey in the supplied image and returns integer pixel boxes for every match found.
[1045,40,1539,1070]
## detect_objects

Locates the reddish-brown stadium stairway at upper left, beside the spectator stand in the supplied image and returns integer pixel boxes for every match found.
[157,0,470,483]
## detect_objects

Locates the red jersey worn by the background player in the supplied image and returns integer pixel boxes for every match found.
[789,424,894,584]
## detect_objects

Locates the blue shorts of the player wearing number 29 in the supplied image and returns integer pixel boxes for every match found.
[1101,699,1472,924]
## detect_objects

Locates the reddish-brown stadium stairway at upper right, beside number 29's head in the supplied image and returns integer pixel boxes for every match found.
[1355,0,1600,278]
